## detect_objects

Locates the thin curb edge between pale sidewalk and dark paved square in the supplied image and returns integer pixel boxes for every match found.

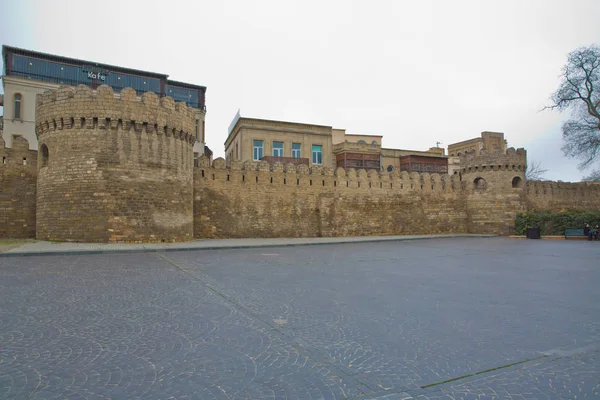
[0,234,498,258]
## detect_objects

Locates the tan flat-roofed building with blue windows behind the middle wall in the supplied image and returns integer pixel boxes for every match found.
[225,112,448,173]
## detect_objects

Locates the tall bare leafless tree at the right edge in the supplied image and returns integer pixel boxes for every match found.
[545,45,600,169]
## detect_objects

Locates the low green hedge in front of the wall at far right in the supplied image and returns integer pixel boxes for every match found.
[515,210,600,235]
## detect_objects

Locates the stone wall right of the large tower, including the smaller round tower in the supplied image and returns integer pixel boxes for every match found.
[194,148,527,238]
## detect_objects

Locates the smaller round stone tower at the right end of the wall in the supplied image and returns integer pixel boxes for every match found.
[455,147,527,235]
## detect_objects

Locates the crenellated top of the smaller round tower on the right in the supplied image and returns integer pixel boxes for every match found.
[460,147,527,174]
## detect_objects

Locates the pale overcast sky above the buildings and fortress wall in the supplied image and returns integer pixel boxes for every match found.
[0,0,600,181]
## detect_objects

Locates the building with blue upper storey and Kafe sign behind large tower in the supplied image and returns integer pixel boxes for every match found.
[2,45,206,154]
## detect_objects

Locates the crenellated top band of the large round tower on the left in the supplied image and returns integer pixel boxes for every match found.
[36,85,195,143]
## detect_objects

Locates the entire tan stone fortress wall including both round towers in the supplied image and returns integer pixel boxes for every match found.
[0,86,600,242]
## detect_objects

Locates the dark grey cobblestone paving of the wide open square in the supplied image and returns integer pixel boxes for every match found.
[0,238,600,399]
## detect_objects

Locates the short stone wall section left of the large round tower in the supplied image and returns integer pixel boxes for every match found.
[0,136,37,239]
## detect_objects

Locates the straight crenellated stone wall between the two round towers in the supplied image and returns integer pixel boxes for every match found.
[194,159,467,238]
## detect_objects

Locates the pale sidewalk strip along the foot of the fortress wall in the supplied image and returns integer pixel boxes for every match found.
[0,234,496,257]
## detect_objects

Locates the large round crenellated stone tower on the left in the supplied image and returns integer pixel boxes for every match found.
[36,85,195,243]
